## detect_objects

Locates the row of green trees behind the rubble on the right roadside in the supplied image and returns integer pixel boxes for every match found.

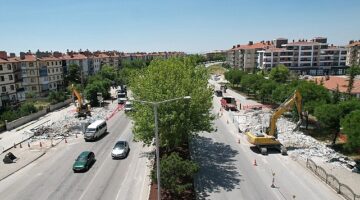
[225,65,360,150]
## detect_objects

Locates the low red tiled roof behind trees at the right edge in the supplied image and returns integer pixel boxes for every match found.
[314,76,360,94]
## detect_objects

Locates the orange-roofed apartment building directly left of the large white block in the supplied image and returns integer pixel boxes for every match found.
[226,41,272,72]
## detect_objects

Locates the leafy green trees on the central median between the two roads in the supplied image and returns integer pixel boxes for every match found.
[129,56,214,199]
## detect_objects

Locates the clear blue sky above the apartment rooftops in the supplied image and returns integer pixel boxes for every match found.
[0,0,360,53]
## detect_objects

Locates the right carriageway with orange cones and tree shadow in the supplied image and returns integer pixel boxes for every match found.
[192,86,342,200]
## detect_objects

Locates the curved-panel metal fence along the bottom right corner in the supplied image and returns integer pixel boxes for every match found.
[306,159,360,200]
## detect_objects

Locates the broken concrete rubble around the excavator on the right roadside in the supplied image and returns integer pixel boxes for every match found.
[234,110,355,166]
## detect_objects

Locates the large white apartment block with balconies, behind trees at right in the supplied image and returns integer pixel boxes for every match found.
[258,37,347,76]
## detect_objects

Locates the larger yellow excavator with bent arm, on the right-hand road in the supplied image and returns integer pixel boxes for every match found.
[245,90,302,155]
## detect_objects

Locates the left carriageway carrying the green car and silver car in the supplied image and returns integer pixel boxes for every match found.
[0,109,151,200]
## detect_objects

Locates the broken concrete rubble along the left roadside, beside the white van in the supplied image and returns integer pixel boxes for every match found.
[24,104,117,141]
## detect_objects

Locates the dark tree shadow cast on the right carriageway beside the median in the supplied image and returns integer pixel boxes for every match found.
[191,137,241,199]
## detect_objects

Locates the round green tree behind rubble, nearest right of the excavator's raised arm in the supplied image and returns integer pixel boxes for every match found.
[314,104,341,144]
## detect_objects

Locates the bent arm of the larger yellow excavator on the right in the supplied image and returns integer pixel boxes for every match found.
[268,90,302,137]
